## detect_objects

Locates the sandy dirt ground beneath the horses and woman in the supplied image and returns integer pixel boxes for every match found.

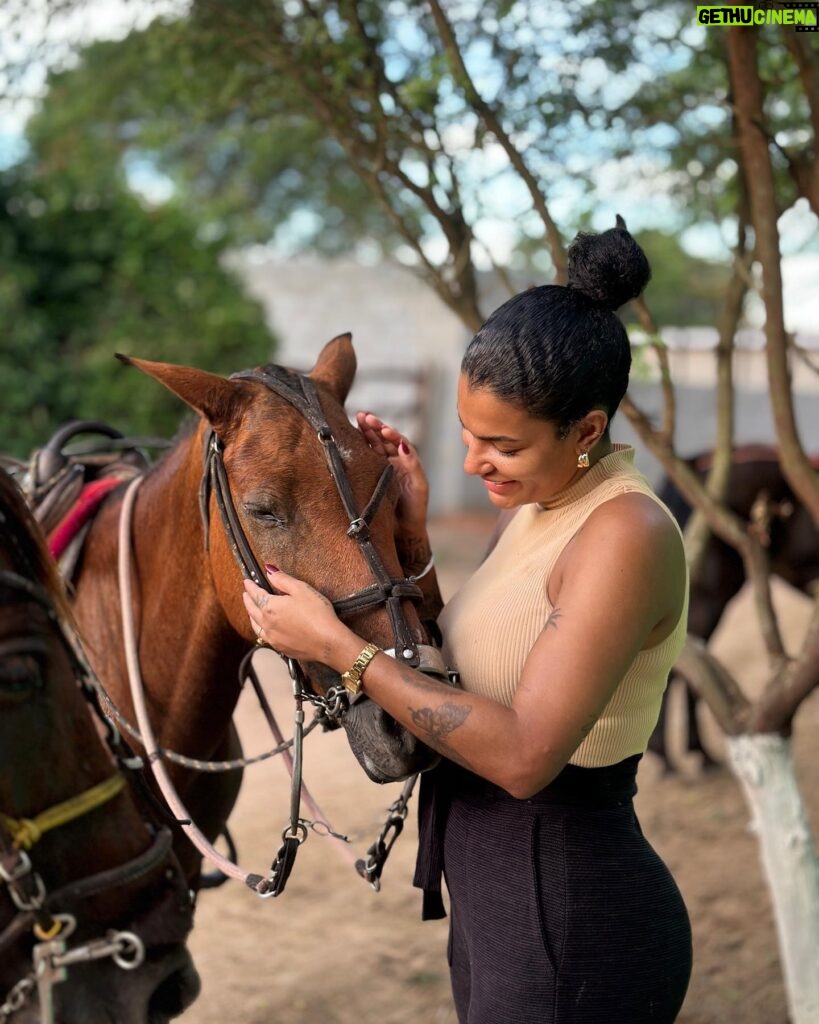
[183,516,819,1024]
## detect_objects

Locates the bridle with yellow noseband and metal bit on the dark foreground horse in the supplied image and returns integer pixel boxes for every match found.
[0,569,192,1024]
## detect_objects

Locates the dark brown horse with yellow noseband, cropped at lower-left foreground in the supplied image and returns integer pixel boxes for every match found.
[0,470,199,1024]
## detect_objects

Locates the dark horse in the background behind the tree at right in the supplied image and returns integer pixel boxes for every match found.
[649,444,819,770]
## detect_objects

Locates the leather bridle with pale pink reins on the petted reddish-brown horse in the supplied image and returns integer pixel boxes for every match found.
[100,367,447,898]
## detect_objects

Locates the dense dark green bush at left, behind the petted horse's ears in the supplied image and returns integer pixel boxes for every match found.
[0,161,273,456]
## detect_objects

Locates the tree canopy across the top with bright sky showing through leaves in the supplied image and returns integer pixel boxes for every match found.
[3,0,816,368]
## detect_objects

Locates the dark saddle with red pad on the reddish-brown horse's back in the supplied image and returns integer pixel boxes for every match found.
[15,420,165,582]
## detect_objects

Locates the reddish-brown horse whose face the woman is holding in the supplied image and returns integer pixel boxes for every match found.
[65,335,436,885]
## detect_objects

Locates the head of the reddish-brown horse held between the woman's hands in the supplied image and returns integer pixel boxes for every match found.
[120,335,437,782]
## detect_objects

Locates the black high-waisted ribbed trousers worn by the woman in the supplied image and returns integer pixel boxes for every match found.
[422,756,691,1024]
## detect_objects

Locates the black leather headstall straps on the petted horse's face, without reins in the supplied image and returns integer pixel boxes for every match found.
[200,368,423,668]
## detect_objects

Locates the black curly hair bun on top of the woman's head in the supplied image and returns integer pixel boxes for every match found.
[568,214,651,310]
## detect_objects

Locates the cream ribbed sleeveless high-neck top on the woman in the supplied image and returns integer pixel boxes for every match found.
[438,444,688,768]
